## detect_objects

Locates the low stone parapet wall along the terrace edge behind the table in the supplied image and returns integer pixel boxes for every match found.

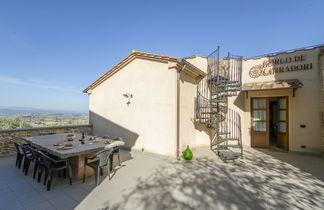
[0,125,92,157]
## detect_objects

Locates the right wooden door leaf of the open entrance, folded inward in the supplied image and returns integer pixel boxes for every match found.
[277,97,289,151]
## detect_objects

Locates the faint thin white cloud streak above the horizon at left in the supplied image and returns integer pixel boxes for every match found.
[0,76,81,93]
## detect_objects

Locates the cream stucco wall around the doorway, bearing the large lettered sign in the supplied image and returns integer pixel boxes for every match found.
[229,48,323,153]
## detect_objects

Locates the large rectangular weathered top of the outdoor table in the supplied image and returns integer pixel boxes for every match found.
[23,133,125,159]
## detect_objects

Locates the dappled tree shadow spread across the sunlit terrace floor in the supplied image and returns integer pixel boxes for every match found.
[101,149,324,209]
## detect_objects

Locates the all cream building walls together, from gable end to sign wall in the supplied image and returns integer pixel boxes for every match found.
[89,49,323,156]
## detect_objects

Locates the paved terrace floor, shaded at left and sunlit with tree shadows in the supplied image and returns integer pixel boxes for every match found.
[0,148,324,210]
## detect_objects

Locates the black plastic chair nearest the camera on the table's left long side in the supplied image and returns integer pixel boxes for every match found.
[38,151,72,191]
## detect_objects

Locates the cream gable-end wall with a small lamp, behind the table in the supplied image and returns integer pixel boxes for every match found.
[89,59,176,156]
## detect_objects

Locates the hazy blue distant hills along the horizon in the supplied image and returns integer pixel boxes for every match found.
[0,106,87,115]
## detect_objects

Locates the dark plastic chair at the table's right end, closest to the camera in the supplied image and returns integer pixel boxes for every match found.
[83,149,112,186]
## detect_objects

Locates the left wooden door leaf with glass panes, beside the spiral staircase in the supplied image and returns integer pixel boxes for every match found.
[251,98,269,147]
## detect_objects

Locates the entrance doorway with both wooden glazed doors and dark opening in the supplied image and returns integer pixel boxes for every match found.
[251,97,289,151]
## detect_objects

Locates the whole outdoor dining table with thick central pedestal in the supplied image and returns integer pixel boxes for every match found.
[22,133,125,180]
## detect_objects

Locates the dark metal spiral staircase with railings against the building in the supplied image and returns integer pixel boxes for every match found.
[195,47,243,161]
